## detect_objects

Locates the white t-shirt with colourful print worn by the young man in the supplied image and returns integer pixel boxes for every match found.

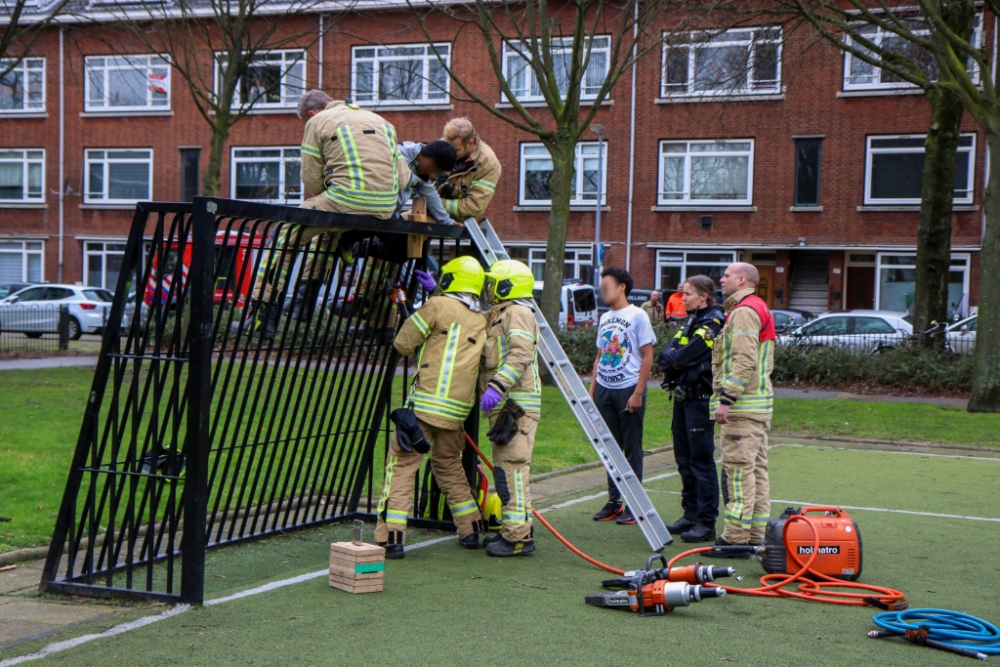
[597,305,656,389]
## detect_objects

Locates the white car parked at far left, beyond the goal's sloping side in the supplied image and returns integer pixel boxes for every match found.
[0,285,112,340]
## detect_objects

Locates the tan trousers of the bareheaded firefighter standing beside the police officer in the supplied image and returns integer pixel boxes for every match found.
[721,416,771,544]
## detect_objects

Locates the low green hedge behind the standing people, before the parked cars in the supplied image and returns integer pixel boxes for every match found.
[559,324,972,392]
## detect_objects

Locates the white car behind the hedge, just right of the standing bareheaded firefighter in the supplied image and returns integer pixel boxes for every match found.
[778,310,913,352]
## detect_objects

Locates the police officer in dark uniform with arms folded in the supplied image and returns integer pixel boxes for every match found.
[659,276,725,542]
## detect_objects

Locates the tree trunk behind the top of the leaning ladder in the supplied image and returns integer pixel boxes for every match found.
[542,143,576,328]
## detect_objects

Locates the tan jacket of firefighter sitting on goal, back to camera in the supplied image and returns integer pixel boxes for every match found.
[302,101,410,220]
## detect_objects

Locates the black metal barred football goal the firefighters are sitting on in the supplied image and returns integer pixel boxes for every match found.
[40,197,478,604]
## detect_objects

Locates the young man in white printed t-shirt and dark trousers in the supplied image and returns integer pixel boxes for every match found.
[590,267,656,525]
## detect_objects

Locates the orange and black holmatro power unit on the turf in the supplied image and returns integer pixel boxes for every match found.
[762,506,861,581]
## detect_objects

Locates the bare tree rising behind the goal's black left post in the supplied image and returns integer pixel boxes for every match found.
[76,0,350,196]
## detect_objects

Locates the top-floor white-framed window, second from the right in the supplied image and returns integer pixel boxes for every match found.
[660,27,781,97]
